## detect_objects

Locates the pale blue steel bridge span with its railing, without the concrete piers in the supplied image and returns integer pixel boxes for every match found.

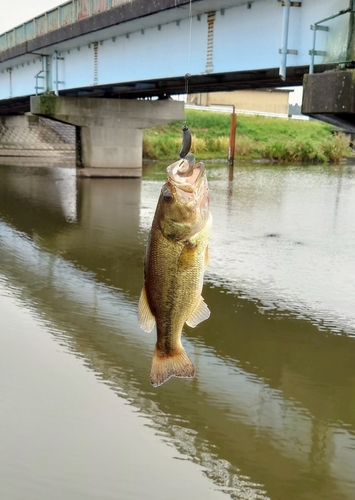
[0,0,355,114]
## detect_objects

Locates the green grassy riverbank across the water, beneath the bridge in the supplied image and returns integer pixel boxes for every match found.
[143,110,352,163]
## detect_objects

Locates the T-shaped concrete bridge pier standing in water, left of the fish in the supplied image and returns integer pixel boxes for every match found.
[31,95,184,177]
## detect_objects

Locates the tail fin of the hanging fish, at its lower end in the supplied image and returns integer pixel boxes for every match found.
[150,346,195,387]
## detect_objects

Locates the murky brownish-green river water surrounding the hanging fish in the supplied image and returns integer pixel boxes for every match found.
[0,161,355,500]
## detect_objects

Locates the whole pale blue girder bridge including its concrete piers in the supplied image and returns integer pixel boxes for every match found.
[0,0,355,176]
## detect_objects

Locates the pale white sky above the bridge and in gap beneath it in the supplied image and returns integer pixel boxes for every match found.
[0,0,302,104]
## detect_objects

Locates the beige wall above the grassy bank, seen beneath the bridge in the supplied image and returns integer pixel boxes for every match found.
[188,89,289,114]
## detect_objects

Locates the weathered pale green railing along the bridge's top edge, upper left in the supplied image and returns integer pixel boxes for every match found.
[0,0,134,52]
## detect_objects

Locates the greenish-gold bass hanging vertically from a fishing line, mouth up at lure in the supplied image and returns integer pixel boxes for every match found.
[138,153,212,387]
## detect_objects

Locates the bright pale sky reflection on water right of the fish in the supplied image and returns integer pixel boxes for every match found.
[209,167,355,333]
